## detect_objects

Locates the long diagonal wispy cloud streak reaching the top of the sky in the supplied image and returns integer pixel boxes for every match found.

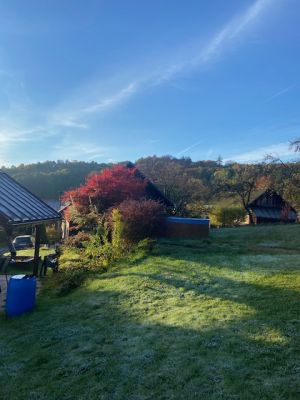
[53,0,275,128]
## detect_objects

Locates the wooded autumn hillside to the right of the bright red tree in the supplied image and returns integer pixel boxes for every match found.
[136,156,300,215]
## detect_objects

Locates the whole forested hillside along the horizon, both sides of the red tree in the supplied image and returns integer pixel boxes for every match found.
[2,156,300,215]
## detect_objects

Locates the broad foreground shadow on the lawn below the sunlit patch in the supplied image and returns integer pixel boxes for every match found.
[0,282,300,400]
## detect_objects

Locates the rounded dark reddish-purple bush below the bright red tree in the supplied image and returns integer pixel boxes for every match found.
[110,200,165,243]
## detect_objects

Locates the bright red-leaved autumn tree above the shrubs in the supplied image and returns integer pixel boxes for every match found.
[63,165,147,213]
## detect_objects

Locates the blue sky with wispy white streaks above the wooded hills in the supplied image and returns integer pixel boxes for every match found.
[0,0,300,165]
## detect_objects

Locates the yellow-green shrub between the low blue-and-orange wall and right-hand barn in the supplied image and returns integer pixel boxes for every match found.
[209,207,247,226]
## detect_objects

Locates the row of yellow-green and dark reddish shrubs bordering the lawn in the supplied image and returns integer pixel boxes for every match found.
[55,200,164,294]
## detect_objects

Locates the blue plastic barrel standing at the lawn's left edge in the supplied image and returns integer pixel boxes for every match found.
[6,275,36,317]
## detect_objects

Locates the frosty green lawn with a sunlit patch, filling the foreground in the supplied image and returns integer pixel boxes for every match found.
[0,225,300,400]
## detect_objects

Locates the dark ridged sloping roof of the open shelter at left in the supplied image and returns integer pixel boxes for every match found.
[0,172,60,225]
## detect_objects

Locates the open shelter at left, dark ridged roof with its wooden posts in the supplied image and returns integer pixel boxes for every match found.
[0,172,61,276]
